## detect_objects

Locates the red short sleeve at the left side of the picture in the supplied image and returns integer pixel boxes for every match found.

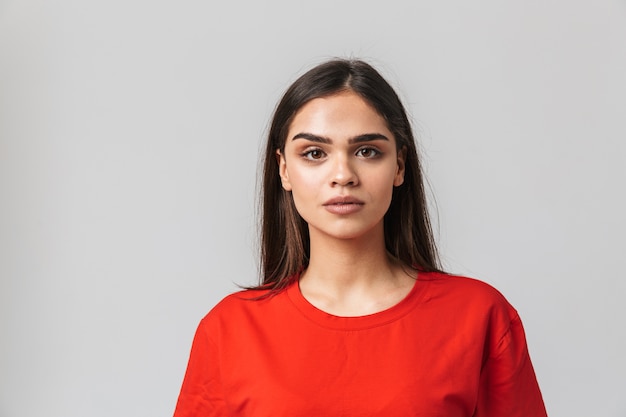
[174,317,228,417]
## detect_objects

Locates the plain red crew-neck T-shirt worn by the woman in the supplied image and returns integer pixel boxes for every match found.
[174,273,546,417]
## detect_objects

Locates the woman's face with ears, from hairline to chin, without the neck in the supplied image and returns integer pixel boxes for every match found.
[277,91,405,239]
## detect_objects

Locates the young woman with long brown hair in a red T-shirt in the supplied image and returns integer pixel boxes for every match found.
[175,60,546,417]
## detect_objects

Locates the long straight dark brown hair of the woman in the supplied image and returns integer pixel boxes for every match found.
[260,59,441,291]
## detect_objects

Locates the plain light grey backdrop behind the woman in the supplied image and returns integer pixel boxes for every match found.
[0,0,626,417]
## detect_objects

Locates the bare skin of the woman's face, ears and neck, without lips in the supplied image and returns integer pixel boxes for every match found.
[277,92,417,317]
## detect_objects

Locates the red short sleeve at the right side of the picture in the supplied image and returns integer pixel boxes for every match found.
[474,315,547,417]
